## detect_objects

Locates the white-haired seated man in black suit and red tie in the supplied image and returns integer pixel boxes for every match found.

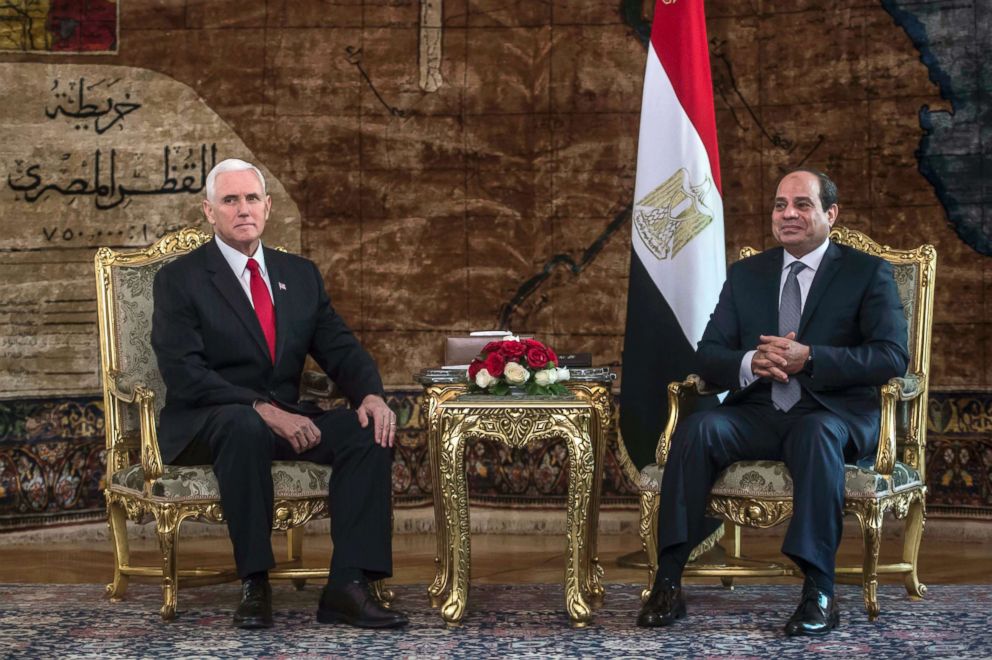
[152,159,407,628]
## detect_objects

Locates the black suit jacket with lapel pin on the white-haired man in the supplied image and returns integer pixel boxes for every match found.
[152,239,383,463]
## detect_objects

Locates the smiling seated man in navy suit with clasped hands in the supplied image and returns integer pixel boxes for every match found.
[637,169,909,636]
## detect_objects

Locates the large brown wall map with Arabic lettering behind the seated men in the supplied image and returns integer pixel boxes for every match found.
[0,0,992,394]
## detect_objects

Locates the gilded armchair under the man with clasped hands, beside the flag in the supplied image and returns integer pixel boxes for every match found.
[639,227,937,620]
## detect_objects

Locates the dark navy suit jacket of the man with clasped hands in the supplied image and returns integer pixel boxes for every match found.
[698,243,909,455]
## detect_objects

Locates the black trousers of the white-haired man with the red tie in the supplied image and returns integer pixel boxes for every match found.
[174,404,393,579]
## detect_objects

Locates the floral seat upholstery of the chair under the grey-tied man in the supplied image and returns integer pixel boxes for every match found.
[638,461,923,499]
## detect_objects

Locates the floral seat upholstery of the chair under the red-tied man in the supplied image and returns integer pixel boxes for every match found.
[111,461,331,501]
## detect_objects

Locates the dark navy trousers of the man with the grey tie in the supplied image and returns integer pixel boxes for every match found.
[658,384,859,580]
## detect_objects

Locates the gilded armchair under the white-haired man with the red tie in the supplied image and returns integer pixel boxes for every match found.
[95,229,356,620]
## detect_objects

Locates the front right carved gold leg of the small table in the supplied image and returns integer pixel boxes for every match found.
[565,413,595,628]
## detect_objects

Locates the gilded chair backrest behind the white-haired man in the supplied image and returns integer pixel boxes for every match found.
[95,229,211,476]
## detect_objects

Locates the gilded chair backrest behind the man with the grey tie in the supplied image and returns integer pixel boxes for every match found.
[740,227,937,471]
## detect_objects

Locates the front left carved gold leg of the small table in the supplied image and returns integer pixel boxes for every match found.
[436,419,472,624]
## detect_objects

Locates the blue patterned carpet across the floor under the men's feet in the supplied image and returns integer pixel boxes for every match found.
[0,584,992,660]
